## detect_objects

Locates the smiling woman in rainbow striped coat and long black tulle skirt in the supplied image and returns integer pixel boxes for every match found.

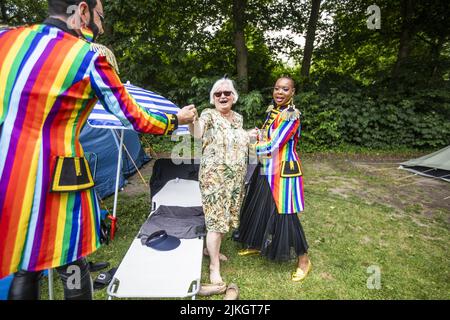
[235,77,311,281]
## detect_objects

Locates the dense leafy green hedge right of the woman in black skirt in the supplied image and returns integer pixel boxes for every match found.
[299,89,450,150]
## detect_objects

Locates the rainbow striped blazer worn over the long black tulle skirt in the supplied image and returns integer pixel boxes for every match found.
[256,107,305,214]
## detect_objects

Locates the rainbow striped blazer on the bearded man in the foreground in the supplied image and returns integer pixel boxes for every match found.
[0,24,176,278]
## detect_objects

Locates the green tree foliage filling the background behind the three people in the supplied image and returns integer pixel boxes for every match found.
[0,0,450,149]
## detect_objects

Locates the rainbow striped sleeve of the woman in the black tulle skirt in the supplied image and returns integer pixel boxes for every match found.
[256,119,300,155]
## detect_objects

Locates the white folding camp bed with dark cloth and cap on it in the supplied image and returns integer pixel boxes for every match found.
[107,178,203,299]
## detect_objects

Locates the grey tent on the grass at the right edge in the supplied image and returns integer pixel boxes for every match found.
[400,146,450,182]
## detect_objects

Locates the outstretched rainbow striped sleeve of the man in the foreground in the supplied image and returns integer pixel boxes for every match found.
[90,54,178,135]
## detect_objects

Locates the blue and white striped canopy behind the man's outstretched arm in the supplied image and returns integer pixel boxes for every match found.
[87,82,189,135]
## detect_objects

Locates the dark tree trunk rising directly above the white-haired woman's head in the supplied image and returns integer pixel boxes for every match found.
[233,0,248,93]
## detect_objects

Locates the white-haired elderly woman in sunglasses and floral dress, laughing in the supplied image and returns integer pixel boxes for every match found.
[190,78,249,284]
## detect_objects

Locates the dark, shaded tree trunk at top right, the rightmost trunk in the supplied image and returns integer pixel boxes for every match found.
[392,0,413,77]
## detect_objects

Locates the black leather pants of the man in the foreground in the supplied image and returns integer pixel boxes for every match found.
[8,258,92,300]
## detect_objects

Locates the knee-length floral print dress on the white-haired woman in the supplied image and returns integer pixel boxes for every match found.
[199,109,249,233]
